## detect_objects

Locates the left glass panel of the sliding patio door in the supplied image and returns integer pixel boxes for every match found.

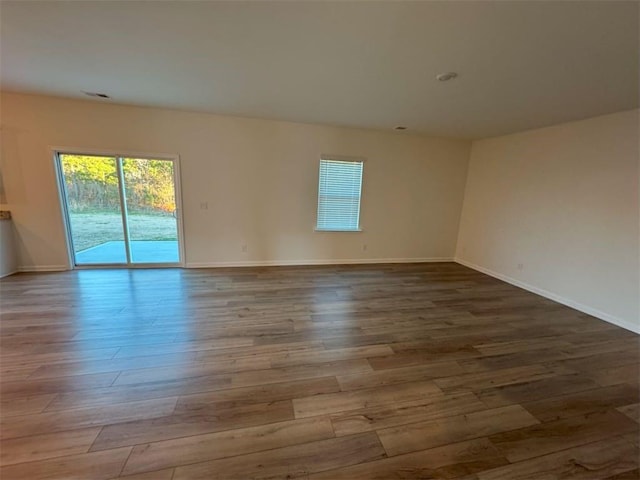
[59,154,127,265]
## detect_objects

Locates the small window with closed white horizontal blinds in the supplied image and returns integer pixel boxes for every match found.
[316,158,363,232]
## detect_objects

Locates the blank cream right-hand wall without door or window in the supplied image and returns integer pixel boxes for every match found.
[456,110,640,332]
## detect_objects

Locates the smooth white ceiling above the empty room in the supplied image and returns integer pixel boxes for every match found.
[0,0,640,138]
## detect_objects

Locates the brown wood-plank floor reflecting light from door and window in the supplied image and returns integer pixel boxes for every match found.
[0,263,640,480]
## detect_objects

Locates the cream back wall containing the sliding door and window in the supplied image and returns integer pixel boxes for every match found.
[1,93,470,270]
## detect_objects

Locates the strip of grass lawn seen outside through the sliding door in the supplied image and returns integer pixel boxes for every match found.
[69,212,178,252]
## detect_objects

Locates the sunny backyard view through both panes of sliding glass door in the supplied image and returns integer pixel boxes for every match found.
[58,153,180,266]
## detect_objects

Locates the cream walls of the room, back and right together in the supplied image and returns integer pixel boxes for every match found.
[0,93,640,331]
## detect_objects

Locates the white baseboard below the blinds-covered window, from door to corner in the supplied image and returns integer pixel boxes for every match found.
[185,257,454,268]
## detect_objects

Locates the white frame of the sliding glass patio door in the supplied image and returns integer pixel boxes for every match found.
[50,147,185,270]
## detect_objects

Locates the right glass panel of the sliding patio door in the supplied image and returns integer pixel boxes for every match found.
[122,158,180,263]
